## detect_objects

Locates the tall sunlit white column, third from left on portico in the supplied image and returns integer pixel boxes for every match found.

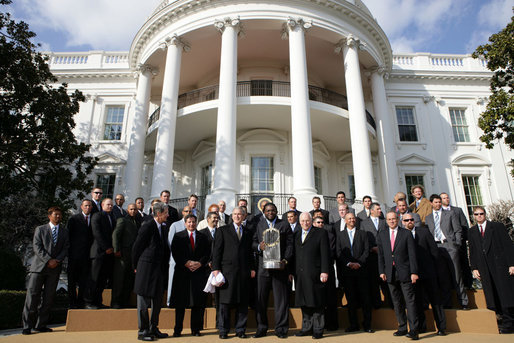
[206,18,241,209]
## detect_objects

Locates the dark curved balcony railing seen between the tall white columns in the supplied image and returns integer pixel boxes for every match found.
[148,80,377,130]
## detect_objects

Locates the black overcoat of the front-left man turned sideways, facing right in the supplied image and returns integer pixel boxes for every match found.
[132,220,170,300]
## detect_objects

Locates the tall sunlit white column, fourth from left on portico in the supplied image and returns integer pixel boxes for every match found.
[287,18,316,209]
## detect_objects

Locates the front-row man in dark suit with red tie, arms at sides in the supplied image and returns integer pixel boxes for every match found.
[377,212,419,340]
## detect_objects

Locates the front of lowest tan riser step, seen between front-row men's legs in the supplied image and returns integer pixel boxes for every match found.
[66,308,498,334]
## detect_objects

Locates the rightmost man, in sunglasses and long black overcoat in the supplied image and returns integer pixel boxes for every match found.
[469,206,514,334]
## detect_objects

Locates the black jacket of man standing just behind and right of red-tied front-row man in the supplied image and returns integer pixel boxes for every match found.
[411,226,439,280]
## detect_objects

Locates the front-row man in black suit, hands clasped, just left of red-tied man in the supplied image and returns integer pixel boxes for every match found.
[336,213,373,333]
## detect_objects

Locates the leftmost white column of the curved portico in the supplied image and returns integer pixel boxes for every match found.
[125,64,153,202]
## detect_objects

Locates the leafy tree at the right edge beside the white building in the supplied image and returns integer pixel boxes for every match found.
[473,17,514,176]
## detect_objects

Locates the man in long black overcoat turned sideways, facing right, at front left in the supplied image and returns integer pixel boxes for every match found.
[132,202,170,341]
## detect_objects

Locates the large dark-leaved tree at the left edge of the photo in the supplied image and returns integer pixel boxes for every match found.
[0,0,96,253]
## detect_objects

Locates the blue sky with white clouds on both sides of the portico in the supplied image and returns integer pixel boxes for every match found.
[2,0,514,54]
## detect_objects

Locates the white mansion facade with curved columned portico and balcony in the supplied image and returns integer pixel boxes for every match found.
[47,0,508,220]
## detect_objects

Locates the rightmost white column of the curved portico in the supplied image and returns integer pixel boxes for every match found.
[371,67,400,203]
